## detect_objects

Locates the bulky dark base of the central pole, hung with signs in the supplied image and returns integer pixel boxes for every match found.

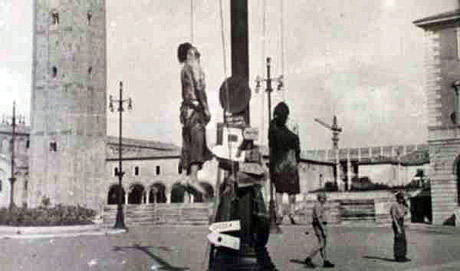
[208,140,278,271]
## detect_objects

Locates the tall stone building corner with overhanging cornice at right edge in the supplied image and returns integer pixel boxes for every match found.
[414,10,460,224]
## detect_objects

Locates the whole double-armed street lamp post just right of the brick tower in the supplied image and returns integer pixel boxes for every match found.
[109,81,133,229]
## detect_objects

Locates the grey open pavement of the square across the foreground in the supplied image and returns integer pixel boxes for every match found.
[0,225,460,271]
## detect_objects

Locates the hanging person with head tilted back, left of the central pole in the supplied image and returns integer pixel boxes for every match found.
[177,42,212,195]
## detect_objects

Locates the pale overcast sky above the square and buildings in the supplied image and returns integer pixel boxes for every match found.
[0,0,458,149]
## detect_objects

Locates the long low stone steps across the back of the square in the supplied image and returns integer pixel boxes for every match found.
[103,199,392,227]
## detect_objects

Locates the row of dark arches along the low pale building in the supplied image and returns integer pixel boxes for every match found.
[107,182,214,205]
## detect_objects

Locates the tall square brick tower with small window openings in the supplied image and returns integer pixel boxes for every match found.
[28,0,107,209]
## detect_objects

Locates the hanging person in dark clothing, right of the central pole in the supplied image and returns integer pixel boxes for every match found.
[268,102,300,224]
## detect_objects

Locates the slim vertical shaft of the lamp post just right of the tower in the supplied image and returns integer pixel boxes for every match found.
[114,82,126,229]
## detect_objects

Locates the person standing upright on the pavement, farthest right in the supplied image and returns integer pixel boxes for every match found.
[390,191,409,262]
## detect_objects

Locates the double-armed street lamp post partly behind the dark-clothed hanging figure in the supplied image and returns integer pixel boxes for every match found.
[256,57,283,233]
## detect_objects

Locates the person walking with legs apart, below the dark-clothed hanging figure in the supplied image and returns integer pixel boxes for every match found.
[305,192,335,268]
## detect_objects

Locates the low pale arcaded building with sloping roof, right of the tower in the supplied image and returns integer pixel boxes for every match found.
[104,136,216,204]
